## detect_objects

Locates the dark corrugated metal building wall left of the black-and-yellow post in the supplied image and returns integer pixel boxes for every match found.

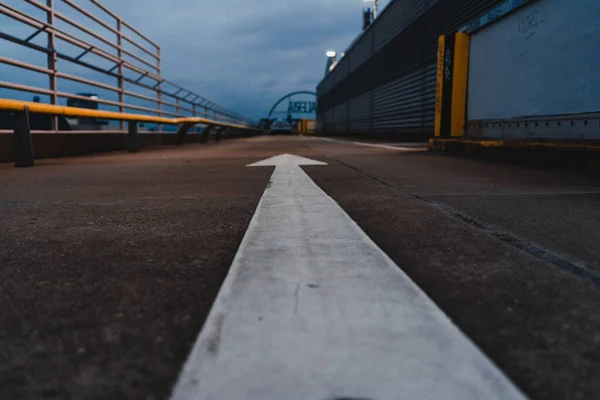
[318,0,504,135]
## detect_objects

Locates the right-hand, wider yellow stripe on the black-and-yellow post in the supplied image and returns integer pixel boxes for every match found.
[450,33,470,136]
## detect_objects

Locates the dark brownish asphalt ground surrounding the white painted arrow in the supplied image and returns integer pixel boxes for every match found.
[0,137,600,400]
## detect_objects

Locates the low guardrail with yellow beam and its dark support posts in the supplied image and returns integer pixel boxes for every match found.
[0,99,257,167]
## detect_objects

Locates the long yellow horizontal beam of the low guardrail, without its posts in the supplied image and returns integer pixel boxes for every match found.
[0,99,248,129]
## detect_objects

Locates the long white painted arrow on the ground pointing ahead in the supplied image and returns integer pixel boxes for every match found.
[172,154,524,400]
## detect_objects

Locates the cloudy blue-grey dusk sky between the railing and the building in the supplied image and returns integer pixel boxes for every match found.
[0,0,389,119]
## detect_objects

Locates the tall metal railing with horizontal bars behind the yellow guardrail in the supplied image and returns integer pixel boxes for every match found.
[0,0,253,132]
